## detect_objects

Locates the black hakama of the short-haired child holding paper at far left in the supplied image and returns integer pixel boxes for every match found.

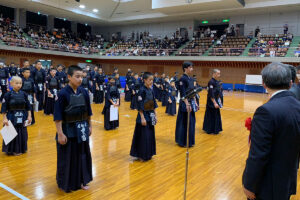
[2,126,28,155]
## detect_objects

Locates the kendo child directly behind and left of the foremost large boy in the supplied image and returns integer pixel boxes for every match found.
[44,68,61,115]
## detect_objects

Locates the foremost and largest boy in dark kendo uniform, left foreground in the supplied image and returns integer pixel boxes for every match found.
[54,65,93,192]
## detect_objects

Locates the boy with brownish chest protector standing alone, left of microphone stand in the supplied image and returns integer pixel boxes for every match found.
[130,72,158,161]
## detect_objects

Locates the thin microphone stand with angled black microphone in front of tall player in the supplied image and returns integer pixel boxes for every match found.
[182,87,202,200]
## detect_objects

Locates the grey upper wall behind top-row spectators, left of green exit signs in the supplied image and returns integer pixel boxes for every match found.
[92,20,194,39]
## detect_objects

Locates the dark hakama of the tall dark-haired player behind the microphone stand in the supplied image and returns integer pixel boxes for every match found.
[175,101,196,147]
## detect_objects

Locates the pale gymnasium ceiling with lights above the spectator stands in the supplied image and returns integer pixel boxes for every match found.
[0,0,300,25]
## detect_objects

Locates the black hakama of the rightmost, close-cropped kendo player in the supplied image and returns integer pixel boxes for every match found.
[203,107,222,134]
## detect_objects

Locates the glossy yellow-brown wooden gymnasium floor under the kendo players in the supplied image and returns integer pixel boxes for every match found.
[0,91,300,200]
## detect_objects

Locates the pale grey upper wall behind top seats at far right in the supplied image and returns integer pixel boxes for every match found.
[230,11,300,36]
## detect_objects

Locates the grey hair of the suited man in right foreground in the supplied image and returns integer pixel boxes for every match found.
[261,62,292,89]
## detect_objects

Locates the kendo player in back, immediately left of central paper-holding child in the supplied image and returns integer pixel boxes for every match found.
[94,67,105,104]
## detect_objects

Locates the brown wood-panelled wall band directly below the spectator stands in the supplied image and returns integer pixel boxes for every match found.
[0,50,276,86]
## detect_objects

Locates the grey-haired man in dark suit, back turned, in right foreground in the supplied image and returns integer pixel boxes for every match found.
[243,63,300,200]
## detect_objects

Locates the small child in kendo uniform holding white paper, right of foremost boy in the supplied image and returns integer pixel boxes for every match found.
[104,74,120,130]
